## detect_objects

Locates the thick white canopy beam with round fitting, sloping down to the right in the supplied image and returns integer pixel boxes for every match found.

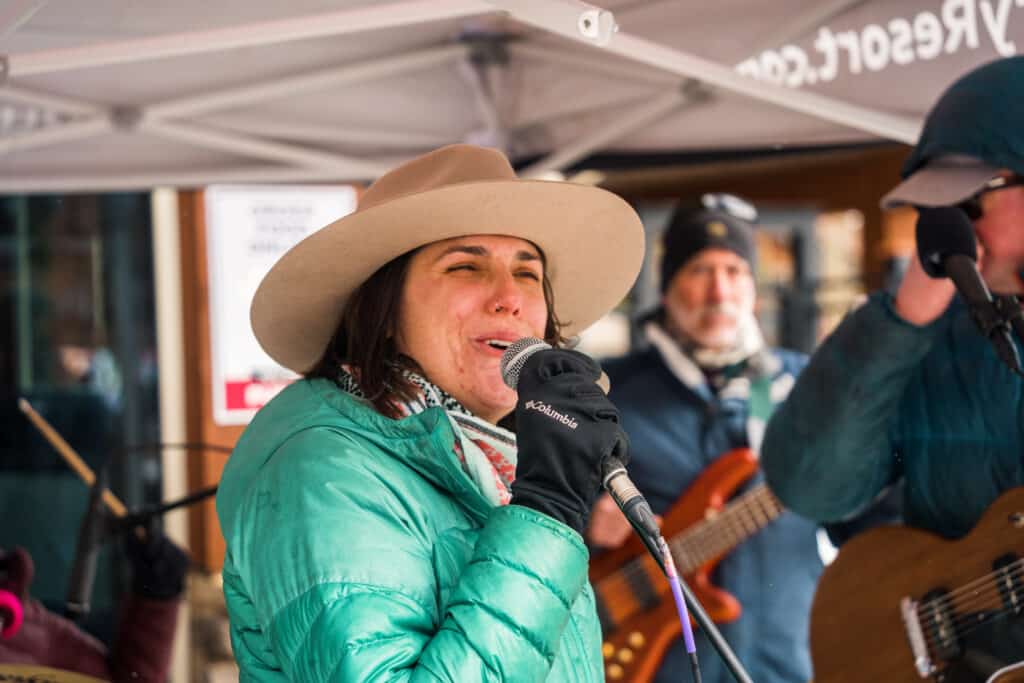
[486,0,921,144]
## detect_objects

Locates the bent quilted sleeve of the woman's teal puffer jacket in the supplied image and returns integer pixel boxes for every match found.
[229,429,588,683]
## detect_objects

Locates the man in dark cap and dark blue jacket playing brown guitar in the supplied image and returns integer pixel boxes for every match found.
[762,56,1024,680]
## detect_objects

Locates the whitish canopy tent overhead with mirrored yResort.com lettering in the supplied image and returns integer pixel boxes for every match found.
[0,0,1024,194]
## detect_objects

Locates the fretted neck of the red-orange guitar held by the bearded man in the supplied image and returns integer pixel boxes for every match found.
[669,483,782,574]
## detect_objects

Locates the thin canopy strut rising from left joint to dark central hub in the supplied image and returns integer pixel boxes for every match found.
[146,44,467,119]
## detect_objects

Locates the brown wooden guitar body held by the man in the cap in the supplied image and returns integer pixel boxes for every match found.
[811,488,1024,683]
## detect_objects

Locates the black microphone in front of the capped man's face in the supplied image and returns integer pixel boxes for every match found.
[916,207,1024,375]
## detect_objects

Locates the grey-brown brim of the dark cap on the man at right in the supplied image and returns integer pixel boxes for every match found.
[881,162,999,209]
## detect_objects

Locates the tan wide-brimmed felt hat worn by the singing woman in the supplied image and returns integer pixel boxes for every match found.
[250,144,644,373]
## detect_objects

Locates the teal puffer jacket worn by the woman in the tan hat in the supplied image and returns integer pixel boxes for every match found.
[217,380,603,683]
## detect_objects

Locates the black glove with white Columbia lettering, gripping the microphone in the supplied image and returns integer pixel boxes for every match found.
[512,349,629,535]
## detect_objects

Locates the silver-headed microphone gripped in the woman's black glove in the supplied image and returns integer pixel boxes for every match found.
[501,337,662,544]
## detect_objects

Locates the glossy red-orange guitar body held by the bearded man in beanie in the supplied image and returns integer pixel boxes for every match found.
[590,449,758,683]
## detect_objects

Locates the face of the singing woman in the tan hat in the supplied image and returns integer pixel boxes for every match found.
[395,234,548,423]
